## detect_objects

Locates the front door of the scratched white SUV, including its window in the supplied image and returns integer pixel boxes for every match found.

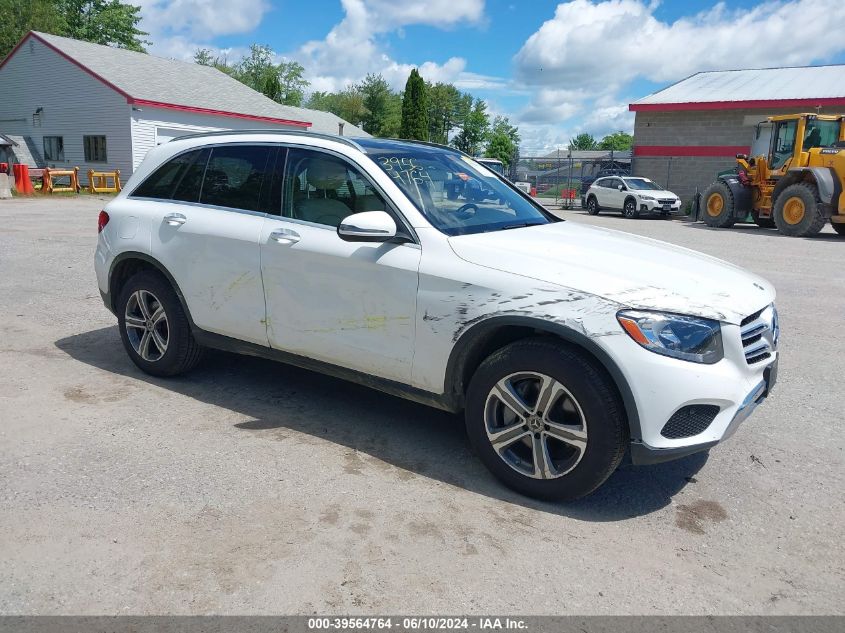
[260,148,420,382]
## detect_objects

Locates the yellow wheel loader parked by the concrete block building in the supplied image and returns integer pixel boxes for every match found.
[701,114,845,237]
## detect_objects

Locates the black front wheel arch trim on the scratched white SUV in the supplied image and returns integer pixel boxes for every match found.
[443,316,642,440]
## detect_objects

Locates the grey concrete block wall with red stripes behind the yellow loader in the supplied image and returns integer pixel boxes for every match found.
[632,107,842,202]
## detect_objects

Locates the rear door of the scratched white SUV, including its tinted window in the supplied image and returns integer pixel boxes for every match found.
[142,144,278,345]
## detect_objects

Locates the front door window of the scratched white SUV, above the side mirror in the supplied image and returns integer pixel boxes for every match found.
[282,149,388,227]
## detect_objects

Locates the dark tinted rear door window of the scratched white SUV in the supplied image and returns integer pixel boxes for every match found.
[200,145,275,211]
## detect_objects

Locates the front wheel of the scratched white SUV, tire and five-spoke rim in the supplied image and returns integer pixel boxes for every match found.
[466,338,628,501]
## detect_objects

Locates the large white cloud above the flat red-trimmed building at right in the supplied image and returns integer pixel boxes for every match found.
[514,0,845,148]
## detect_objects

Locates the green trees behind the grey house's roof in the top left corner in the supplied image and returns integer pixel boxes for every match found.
[0,0,149,59]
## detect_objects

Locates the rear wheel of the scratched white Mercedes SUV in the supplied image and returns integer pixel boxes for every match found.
[117,271,203,376]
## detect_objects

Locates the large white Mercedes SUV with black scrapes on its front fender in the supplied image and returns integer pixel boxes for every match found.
[96,132,778,499]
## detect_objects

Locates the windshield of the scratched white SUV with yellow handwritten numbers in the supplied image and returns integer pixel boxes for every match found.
[367,145,555,235]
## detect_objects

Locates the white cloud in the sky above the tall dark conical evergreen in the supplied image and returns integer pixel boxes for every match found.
[288,0,502,91]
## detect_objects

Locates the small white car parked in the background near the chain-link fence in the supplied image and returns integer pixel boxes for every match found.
[586,176,681,218]
